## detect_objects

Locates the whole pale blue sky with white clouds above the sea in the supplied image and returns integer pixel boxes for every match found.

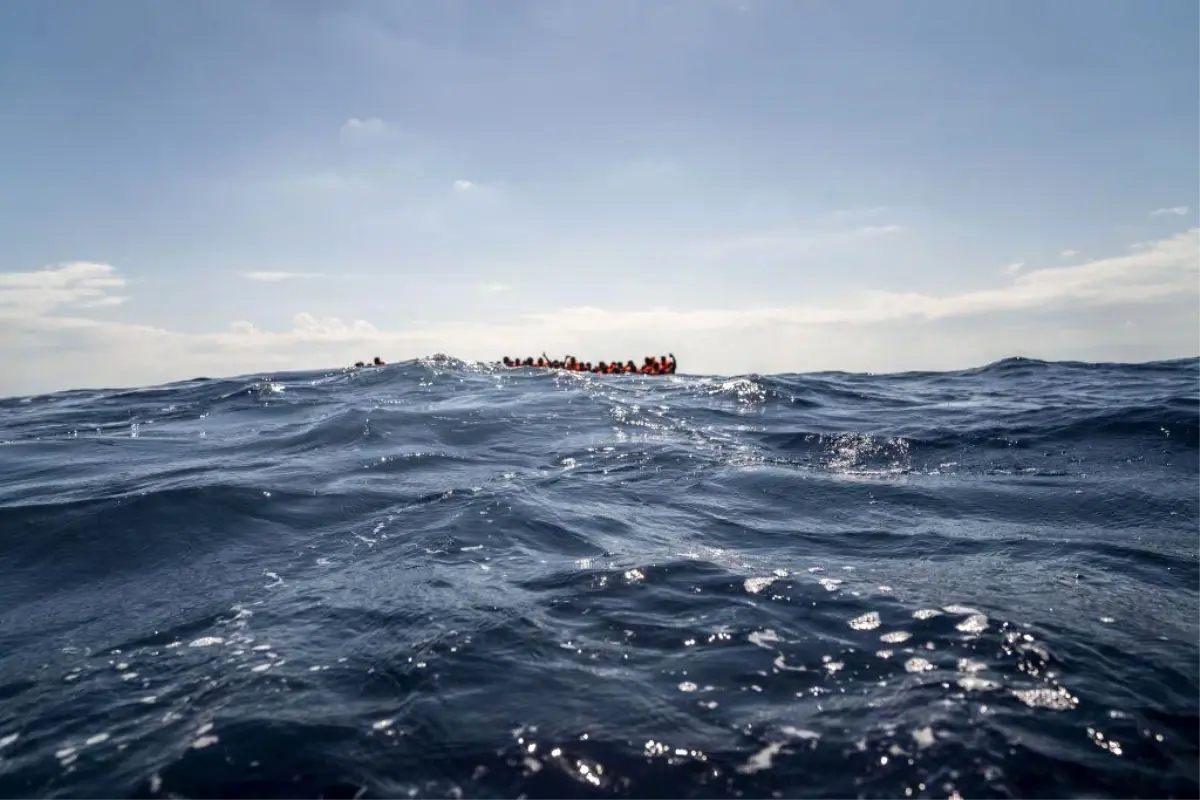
[0,0,1200,396]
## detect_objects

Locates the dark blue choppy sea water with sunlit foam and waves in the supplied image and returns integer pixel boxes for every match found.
[0,357,1200,800]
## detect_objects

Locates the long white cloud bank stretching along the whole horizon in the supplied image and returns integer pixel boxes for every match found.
[0,228,1200,395]
